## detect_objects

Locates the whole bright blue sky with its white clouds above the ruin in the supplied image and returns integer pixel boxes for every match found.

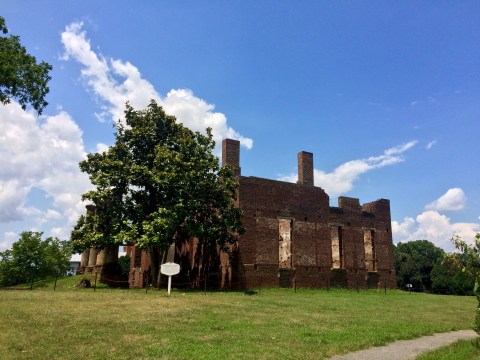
[0,0,480,251]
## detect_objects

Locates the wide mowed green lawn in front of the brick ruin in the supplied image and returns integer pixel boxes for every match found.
[0,277,476,359]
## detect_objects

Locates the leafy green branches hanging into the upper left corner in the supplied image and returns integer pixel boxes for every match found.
[0,17,52,114]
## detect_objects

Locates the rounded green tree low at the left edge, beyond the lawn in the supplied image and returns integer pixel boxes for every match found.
[0,231,72,286]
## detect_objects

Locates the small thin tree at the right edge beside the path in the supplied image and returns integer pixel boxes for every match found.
[450,234,480,348]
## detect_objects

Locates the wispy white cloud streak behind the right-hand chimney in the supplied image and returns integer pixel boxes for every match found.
[279,141,417,197]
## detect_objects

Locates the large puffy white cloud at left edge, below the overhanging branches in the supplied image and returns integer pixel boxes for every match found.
[0,101,90,238]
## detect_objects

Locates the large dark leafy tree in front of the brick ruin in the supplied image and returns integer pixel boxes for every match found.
[71,101,243,286]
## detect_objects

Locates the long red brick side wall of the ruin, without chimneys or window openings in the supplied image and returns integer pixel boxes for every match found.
[231,176,395,289]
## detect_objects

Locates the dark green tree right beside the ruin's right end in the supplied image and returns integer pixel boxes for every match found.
[394,240,445,291]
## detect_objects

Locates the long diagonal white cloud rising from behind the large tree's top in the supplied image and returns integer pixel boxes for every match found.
[62,23,253,153]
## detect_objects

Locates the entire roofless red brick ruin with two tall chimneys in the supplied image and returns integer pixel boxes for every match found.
[78,139,396,289]
